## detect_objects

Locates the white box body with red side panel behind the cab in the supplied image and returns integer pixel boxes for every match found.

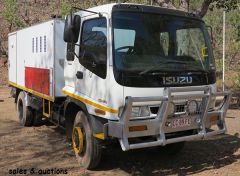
[8,19,65,100]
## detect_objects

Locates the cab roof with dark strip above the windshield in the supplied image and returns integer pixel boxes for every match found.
[80,3,203,21]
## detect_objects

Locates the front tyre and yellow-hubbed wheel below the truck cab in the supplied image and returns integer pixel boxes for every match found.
[72,111,102,169]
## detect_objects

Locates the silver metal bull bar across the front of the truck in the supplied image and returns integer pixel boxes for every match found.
[108,86,231,151]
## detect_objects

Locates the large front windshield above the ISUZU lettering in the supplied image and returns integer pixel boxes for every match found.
[113,12,215,75]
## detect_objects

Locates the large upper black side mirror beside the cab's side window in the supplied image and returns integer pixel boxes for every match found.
[63,13,81,43]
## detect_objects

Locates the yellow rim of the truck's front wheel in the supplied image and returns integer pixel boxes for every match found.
[72,127,84,155]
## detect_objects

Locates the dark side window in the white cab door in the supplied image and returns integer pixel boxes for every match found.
[80,18,107,79]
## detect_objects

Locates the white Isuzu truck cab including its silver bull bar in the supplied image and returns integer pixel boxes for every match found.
[63,4,230,168]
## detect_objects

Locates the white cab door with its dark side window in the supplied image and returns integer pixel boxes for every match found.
[76,17,107,101]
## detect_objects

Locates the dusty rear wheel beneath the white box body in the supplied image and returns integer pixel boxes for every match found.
[17,92,33,126]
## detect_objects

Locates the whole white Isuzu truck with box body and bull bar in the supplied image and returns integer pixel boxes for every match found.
[9,3,231,169]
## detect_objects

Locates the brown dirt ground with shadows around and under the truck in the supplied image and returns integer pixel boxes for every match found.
[0,87,240,176]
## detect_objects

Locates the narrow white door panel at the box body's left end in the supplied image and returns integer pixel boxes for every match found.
[8,33,17,83]
